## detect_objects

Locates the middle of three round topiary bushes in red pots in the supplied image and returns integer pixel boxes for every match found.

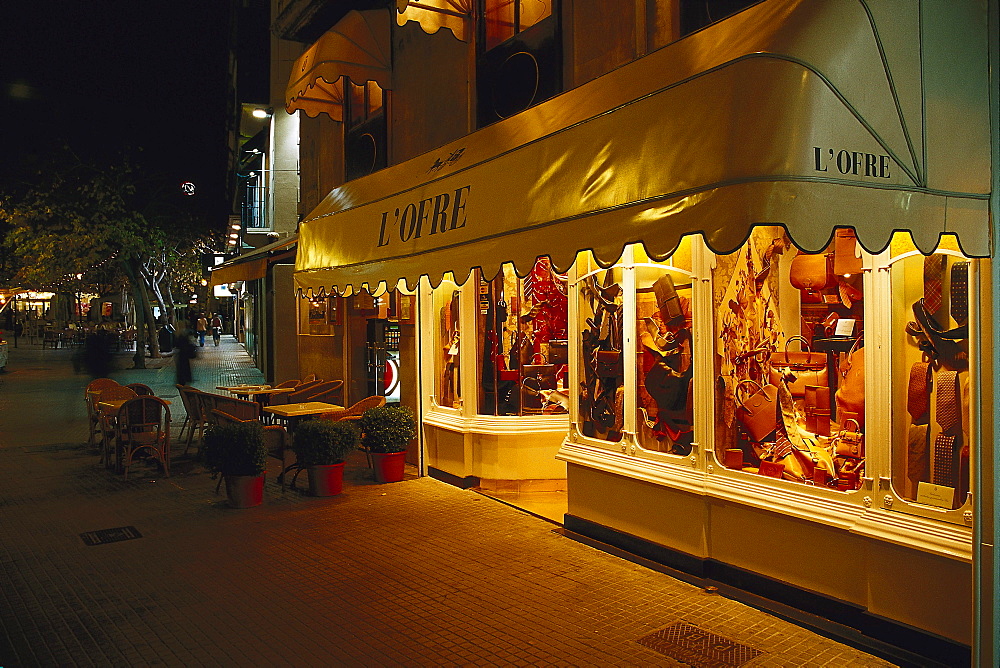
[292,419,358,496]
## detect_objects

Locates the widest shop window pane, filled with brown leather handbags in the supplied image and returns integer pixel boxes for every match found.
[713,227,865,491]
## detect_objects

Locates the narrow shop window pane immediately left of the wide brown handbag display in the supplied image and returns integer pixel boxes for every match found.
[633,237,694,455]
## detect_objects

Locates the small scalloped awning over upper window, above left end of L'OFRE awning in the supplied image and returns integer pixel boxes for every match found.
[285,9,392,120]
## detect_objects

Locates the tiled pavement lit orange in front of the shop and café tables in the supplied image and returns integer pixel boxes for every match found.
[0,336,890,668]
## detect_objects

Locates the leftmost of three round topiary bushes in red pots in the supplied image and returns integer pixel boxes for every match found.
[205,421,267,508]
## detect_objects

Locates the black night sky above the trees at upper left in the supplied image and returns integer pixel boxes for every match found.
[0,0,238,225]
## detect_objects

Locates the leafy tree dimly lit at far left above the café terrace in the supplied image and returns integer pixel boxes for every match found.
[0,151,223,366]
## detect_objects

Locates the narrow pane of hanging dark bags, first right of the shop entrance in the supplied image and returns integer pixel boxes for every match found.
[575,254,625,442]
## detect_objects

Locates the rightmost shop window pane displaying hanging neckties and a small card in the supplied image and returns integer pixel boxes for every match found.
[889,233,974,510]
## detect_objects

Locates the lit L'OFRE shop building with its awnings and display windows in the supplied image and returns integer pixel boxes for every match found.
[238,0,998,665]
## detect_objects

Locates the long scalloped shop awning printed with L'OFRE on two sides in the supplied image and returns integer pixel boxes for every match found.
[296,0,990,293]
